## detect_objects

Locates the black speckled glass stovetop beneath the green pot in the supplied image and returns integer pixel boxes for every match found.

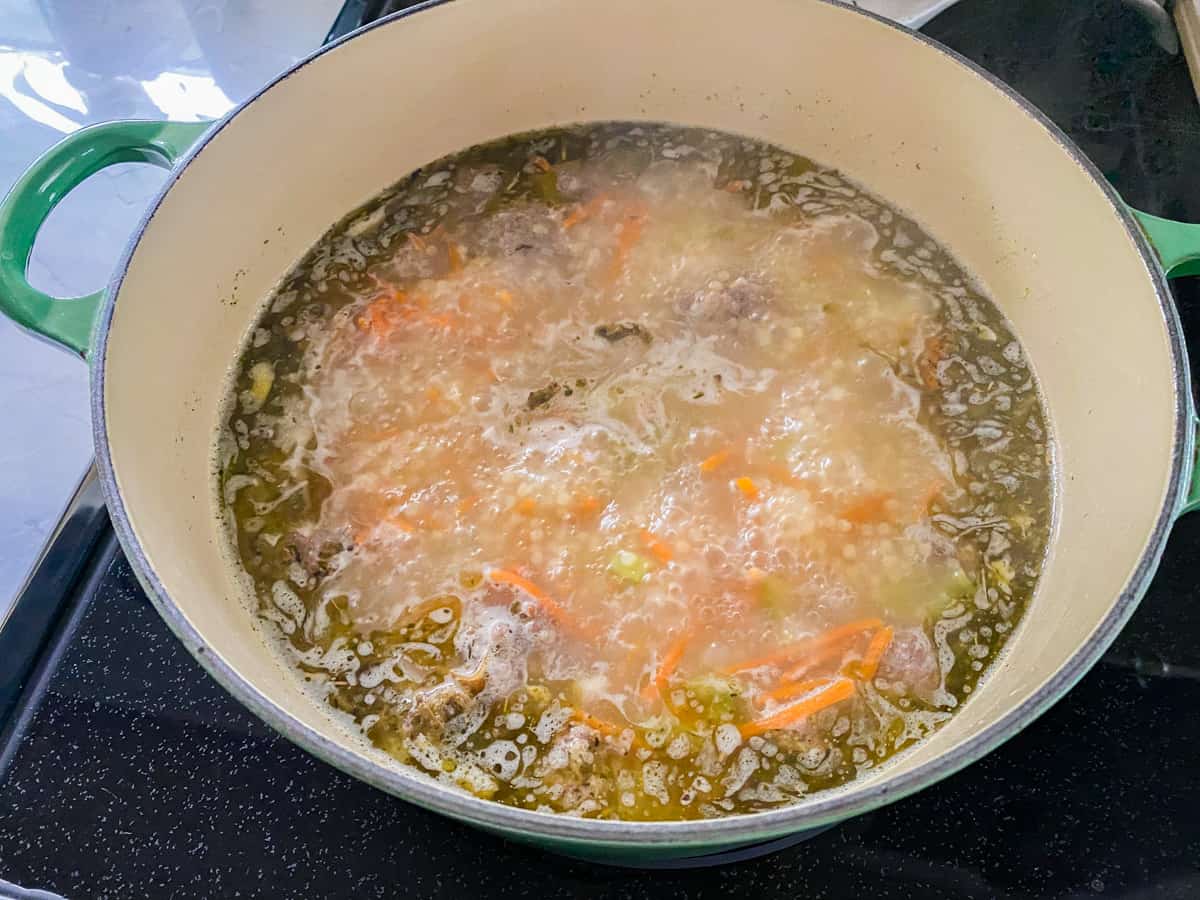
[0,0,1200,900]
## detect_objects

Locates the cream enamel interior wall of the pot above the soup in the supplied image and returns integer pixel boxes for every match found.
[98,0,1181,844]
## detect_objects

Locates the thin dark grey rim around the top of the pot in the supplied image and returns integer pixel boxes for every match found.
[90,0,1194,847]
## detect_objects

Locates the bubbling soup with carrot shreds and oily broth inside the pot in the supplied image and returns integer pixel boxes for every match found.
[220,124,1051,820]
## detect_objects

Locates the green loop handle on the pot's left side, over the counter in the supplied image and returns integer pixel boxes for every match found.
[0,121,211,358]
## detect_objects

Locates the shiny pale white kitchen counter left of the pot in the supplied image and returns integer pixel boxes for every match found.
[0,0,342,623]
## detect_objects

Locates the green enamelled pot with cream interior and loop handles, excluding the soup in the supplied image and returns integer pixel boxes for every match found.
[0,0,1200,864]
